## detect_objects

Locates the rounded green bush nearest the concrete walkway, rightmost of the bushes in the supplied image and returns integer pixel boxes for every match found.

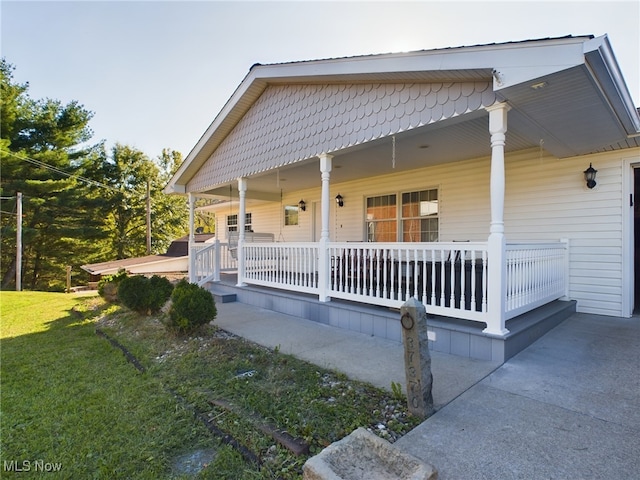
[168,279,218,333]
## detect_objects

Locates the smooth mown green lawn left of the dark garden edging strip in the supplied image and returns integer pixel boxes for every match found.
[0,292,220,479]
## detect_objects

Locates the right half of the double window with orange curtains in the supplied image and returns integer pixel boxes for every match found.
[401,188,438,242]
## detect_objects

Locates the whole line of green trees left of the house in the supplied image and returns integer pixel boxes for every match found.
[0,58,189,290]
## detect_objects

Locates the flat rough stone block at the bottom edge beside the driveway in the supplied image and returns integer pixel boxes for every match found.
[302,428,438,480]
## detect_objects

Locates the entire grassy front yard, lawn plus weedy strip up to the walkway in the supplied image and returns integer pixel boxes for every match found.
[0,292,418,479]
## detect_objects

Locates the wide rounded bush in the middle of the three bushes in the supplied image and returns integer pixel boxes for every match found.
[118,275,173,315]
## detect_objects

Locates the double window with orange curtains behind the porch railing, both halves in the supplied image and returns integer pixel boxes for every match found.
[366,188,439,242]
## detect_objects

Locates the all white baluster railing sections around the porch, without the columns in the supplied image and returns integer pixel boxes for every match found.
[192,242,568,330]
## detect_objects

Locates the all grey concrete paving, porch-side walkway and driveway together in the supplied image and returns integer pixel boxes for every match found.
[216,303,640,480]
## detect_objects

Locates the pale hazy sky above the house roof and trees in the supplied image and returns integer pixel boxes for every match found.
[0,0,640,158]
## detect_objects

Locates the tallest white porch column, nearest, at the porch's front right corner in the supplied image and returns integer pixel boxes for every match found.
[484,103,509,336]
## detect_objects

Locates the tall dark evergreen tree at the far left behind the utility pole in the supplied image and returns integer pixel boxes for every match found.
[0,59,100,289]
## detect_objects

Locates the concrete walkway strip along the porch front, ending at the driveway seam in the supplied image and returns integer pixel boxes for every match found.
[215,302,498,409]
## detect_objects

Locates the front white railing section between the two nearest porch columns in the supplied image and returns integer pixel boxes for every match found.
[329,242,487,321]
